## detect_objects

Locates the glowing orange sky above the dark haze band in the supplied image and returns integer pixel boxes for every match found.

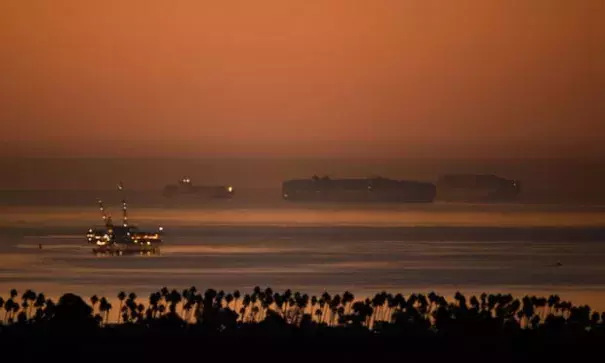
[0,0,605,157]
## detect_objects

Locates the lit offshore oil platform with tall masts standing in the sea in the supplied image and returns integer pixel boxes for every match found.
[86,183,164,255]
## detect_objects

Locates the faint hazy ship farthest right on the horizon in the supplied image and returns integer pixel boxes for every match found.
[437,174,521,202]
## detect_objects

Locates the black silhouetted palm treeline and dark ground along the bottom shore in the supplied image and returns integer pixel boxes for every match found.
[0,287,605,362]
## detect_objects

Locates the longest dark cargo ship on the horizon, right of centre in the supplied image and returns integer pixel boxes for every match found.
[282,175,436,203]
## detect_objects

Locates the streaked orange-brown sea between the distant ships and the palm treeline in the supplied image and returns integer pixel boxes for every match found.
[0,200,605,310]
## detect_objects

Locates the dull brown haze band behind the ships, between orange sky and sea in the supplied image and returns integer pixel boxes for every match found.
[0,157,605,205]
